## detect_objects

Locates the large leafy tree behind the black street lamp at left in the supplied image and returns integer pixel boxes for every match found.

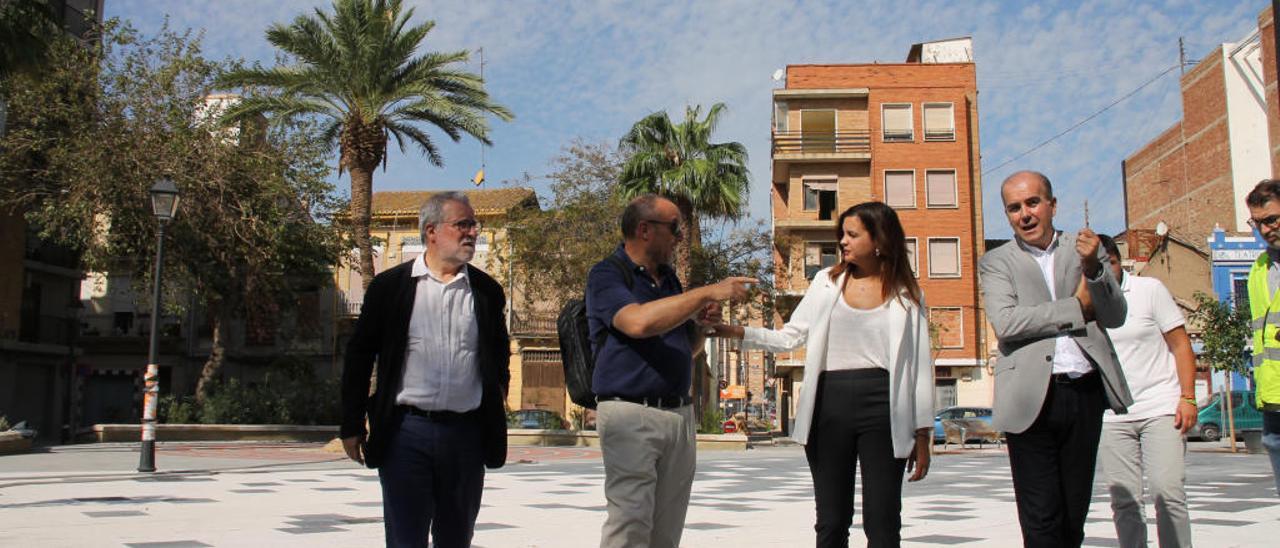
[0,22,347,396]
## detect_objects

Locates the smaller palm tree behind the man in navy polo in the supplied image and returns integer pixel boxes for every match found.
[618,102,750,286]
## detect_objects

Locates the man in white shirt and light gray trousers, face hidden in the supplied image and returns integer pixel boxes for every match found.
[1098,236,1197,548]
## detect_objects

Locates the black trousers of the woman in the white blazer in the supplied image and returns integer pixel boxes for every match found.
[804,367,906,548]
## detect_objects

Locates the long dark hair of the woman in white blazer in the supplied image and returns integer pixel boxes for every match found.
[831,202,920,306]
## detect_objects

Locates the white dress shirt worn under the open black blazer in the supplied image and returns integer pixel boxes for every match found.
[396,255,483,412]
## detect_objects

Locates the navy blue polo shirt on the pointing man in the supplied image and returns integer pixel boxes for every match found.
[586,245,692,398]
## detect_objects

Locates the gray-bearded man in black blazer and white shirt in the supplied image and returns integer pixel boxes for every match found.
[340,192,511,547]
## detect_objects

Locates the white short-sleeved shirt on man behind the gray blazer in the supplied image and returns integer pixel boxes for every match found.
[1102,274,1185,423]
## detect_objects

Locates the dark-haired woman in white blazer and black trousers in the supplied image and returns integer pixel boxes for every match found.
[716,202,933,547]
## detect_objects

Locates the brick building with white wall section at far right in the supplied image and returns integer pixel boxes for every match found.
[1123,8,1280,247]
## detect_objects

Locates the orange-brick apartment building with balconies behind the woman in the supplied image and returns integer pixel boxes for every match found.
[771,38,991,432]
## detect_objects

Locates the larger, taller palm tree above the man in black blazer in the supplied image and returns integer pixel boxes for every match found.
[219,0,513,289]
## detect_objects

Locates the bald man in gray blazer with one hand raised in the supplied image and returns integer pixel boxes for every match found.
[978,172,1133,548]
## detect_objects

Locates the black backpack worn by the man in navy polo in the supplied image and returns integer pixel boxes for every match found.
[556,255,635,410]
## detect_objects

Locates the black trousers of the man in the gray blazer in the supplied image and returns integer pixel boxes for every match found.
[1007,371,1106,548]
